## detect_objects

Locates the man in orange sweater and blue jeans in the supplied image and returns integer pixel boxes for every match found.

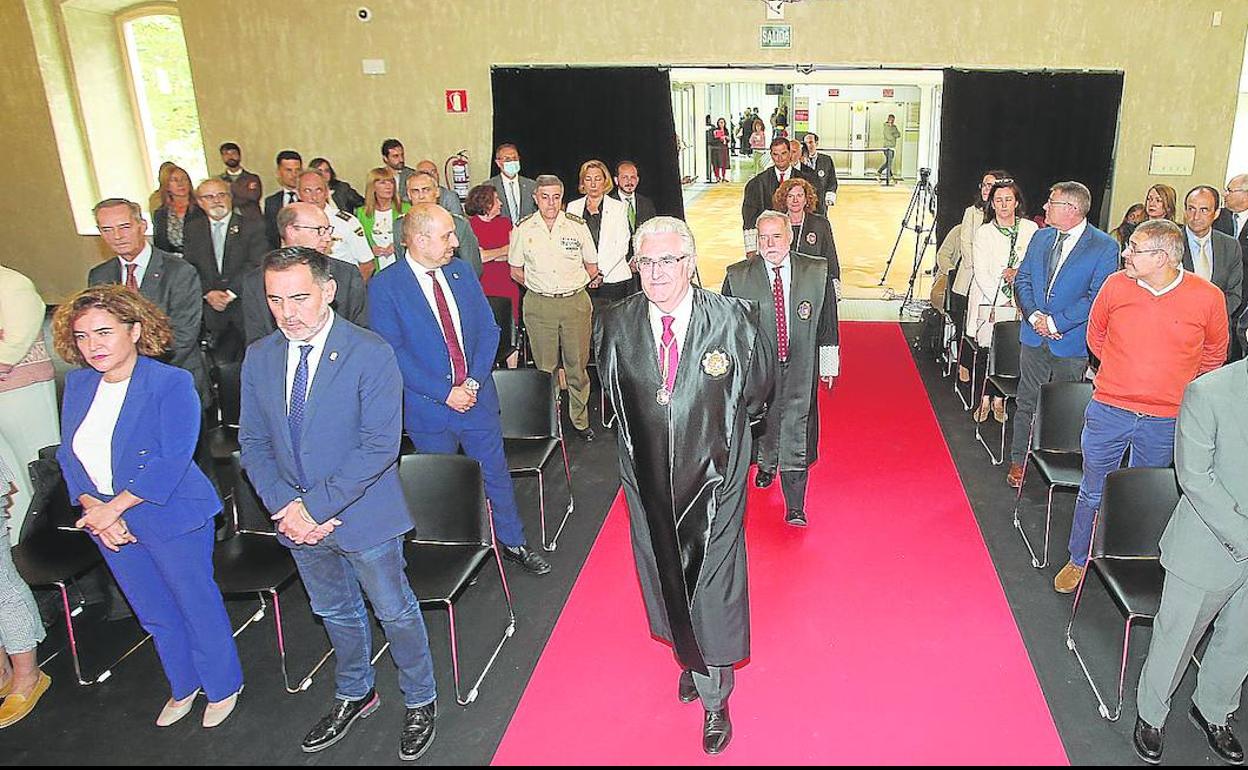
[1053,220,1229,594]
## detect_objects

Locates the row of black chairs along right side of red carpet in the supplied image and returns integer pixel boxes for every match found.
[945,311,1199,721]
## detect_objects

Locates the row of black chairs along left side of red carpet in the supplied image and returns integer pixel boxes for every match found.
[12,363,574,705]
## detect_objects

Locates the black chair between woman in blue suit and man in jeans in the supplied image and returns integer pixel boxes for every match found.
[222,452,333,695]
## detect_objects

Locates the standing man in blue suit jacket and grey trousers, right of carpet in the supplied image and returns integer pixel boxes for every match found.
[1006,182,1118,487]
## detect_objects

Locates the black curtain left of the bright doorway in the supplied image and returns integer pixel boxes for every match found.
[492,67,685,218]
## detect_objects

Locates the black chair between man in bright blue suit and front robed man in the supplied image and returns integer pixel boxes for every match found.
[494,369,577,550]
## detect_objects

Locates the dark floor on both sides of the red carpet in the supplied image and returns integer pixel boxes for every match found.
[7,326,1238,765]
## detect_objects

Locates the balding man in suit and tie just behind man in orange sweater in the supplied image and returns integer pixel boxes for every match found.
[1183,185,1244,347]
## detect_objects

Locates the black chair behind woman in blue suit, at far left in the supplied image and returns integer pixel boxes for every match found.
[13,447,151,686]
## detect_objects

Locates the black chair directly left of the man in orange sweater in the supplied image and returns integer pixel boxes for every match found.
[1013,382,1092,569]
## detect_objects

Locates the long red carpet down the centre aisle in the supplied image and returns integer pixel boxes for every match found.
[494,323,1067,765]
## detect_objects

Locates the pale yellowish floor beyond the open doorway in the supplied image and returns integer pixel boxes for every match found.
[685,163,936,300]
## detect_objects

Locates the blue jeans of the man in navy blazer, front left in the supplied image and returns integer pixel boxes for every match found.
[291,533,438,709]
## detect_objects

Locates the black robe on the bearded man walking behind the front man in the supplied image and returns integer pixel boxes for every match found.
[723,252,840,470]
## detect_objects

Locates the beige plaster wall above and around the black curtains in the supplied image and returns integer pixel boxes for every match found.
[0,0,1248,300]
